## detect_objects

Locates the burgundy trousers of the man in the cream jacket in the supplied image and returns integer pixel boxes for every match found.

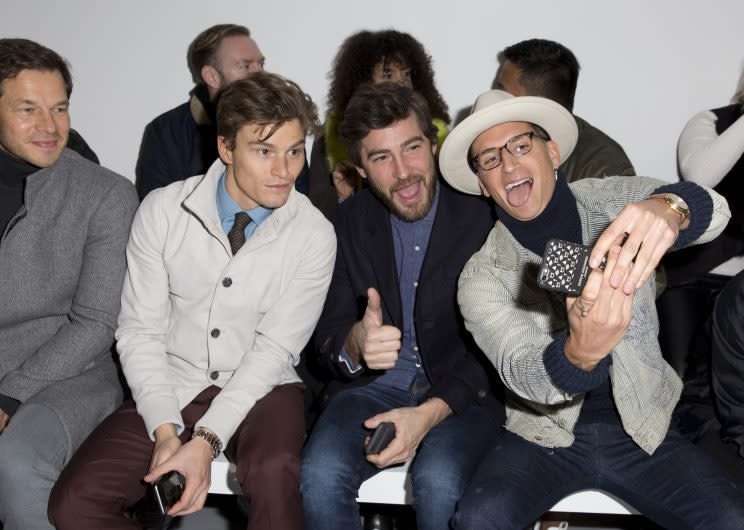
[49,383,305,530]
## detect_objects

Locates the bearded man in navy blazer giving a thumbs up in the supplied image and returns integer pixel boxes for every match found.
[300,83,503,530]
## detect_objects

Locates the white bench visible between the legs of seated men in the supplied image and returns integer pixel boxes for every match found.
[209,455,638,515]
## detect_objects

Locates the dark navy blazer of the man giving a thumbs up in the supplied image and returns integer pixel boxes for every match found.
[315,179,504,418]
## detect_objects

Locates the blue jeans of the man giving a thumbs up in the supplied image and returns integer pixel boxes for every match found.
[300,376,503,530]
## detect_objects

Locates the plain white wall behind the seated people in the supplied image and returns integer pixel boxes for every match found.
[0,0,744,184]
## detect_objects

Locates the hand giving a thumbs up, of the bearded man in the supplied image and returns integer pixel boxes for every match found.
[346,287,401,370]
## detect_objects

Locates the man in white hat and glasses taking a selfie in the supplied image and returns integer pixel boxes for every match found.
[439,90,744,530]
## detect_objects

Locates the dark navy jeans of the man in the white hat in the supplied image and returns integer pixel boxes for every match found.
[453,423,744,530]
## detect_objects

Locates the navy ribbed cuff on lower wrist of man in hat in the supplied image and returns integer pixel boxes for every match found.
[543,335,612,394]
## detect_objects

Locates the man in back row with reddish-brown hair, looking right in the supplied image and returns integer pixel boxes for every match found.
[135,24,308,199]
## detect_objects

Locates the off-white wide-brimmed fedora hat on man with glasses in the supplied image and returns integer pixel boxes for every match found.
[439,90,579,195]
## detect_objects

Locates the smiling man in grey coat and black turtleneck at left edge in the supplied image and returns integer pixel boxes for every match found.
[0,39,137,530]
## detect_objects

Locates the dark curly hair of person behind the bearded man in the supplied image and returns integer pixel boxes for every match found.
[328,29,450,123]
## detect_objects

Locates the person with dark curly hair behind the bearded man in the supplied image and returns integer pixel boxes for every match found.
[310,30,450,214]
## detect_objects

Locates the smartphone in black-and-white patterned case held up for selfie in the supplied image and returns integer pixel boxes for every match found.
[537,239,604,296]
